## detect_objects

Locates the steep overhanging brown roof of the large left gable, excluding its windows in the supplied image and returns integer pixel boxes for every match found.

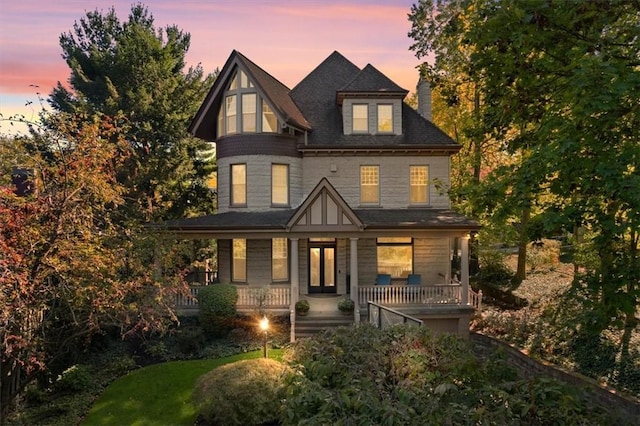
[188,50,310,141]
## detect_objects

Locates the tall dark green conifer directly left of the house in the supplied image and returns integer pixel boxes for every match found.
[49,4,215,221]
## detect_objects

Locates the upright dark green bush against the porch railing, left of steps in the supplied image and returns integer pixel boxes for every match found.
[198,284,238,337]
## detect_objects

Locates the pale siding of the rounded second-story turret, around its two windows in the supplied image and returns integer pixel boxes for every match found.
[218,155,302,213]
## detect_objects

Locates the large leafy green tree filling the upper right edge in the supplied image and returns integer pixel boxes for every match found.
[410,0,640,332]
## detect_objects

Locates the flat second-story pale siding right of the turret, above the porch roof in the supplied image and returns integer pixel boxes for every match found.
[302,156,450,208]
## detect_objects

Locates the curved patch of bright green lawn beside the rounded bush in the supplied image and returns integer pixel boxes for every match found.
[82,349,283,426]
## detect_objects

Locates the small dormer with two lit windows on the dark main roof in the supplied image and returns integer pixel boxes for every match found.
[336,64,408,135]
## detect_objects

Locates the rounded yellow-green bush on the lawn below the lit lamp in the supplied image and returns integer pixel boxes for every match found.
[193,358,287,426]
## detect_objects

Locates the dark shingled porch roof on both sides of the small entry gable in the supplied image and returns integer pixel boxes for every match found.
[163,208,480,233]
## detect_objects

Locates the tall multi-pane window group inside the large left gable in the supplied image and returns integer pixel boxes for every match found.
[217,70,278,137]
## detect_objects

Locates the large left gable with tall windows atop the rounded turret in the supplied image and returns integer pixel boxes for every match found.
[189,50,310,141]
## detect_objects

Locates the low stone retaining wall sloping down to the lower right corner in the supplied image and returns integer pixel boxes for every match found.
[470,332,640,425]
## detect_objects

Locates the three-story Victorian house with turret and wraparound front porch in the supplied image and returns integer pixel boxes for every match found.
[167,51,479,340]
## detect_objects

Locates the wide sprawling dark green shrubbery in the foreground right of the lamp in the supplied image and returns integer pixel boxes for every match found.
[280,324,610,425]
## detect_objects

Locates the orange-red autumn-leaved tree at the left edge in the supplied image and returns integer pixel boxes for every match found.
[0,114,186,420]
